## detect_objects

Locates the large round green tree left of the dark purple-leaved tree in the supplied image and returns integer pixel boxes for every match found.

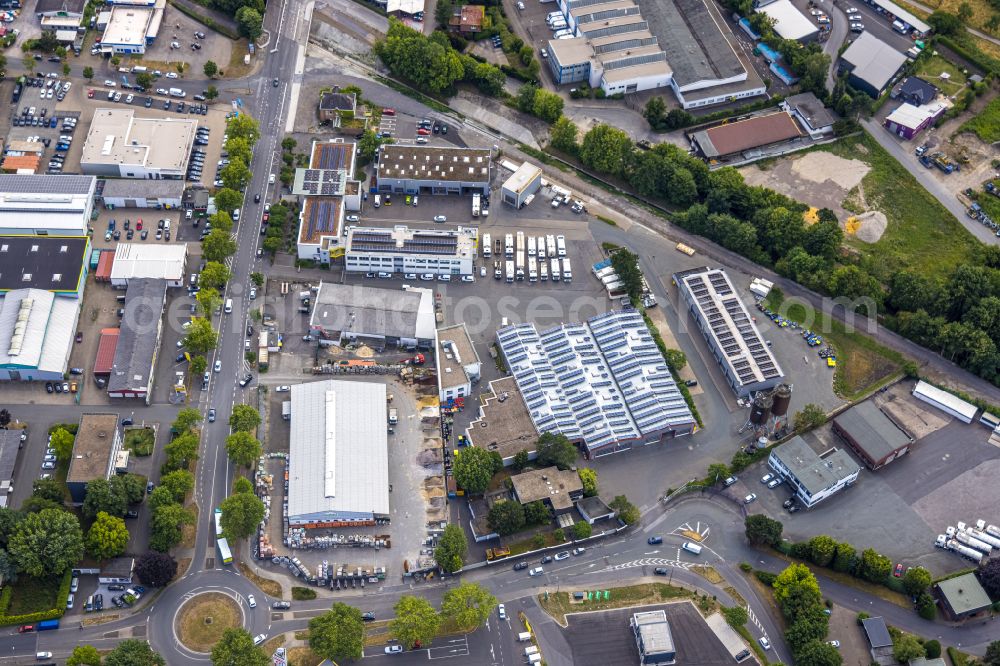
[7,509,83,578]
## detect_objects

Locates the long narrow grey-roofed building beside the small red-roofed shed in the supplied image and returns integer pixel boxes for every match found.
[108,278,167,404]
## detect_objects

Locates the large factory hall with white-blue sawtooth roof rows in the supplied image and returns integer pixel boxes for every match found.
[497,309,695,457]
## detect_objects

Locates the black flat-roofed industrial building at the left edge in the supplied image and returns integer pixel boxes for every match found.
[0,236,90,299]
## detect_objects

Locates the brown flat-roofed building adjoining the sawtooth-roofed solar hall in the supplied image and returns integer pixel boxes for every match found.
[465,377,538,466]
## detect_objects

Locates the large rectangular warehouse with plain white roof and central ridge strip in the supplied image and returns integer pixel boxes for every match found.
[288,379,389,527]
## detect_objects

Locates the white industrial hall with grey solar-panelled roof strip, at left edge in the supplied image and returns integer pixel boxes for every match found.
[0,174,97,236]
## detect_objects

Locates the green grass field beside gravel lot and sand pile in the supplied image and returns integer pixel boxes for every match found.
[823,133,980,282]
